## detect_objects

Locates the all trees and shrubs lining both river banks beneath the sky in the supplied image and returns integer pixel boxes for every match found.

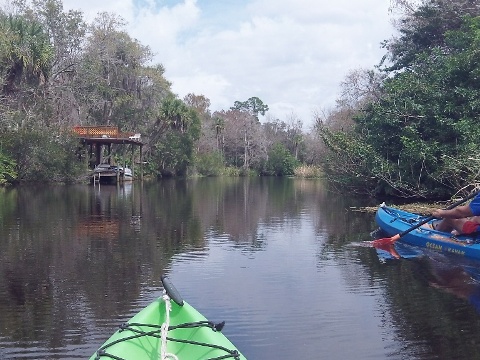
[0,0,480,201]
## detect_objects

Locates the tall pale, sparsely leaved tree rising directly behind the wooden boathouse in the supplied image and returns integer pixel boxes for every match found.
[79,13,155,129]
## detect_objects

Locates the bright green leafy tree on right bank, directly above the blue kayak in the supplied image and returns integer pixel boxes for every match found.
[358,14,480,195]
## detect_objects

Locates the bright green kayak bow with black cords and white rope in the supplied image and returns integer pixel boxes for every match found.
[90,277,245,360]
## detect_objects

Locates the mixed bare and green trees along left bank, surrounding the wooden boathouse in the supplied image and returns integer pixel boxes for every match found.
[0,0,316,184]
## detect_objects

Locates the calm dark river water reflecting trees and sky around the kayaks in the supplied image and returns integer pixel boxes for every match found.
[0,178,480,360]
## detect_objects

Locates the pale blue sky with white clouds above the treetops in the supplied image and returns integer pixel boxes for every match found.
[14,0,394,130]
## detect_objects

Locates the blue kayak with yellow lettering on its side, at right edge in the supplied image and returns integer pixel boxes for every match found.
[375,206,480,259]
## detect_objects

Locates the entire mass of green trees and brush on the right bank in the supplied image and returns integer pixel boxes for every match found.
[317,0,480,197]
